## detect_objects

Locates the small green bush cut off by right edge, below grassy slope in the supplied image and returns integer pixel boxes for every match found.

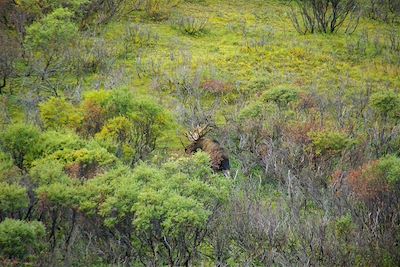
[370,91,400,118]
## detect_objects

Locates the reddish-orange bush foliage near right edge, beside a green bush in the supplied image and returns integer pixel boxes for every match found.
[347,161,389,201]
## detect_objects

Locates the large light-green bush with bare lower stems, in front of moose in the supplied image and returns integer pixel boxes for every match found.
[83,153,229,265]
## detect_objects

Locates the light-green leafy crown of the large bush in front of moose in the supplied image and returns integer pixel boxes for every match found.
[77,153,229,263]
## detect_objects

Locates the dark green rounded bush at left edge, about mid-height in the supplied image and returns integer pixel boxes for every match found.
[0,124,40,169]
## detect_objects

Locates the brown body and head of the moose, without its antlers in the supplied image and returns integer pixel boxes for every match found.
[185,138,230,173]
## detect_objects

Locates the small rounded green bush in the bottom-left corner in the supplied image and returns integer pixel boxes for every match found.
[0,218,45,260]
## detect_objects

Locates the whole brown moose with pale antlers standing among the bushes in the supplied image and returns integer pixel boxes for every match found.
[185,124,230,175]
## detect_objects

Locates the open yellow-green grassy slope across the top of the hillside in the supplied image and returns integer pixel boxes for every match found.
[7,0,400,148]
